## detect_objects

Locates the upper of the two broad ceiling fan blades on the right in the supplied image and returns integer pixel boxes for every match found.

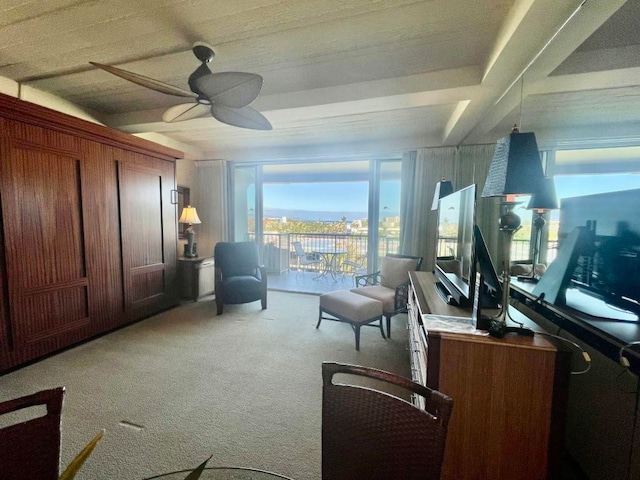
[194,72,262,108]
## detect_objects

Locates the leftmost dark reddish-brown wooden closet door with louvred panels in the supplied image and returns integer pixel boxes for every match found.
[0,141,89,348]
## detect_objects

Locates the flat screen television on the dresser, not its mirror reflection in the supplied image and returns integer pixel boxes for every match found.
[434,184,476,306]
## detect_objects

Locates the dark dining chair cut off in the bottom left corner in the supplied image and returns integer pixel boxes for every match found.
[0,387,64,480]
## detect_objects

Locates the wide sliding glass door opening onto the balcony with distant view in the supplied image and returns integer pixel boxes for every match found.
[229,160,400,292]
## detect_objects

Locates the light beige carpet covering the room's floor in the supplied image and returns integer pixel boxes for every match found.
[0,292,409,480]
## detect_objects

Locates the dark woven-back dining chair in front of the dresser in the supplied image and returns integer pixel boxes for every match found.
[322,362,453,480]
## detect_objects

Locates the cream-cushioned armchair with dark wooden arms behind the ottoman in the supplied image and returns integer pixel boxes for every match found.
[351,254,422,338]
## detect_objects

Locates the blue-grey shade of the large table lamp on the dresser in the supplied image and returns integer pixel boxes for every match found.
[482,128,544,197]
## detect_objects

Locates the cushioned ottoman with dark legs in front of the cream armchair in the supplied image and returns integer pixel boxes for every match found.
[316,290,387,350]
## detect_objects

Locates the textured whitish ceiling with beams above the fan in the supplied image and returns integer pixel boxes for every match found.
[0,0,640,159]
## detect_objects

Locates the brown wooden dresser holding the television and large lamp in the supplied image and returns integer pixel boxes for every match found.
[408,272,571,480]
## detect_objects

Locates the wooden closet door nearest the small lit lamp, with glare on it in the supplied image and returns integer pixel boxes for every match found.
[118,162,177,316]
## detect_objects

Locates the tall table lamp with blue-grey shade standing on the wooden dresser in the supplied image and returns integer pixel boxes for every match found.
[482,126,544,337]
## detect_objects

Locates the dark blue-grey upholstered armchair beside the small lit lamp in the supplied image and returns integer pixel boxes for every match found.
[213,242,267,315]
